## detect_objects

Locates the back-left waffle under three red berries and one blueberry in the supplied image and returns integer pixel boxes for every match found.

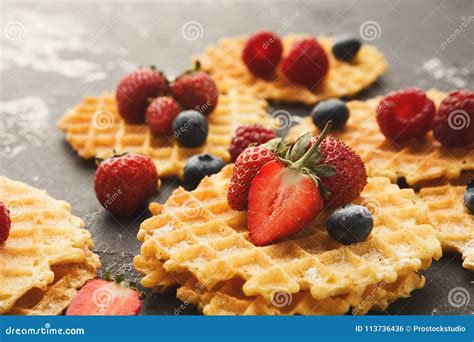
[58,91,271,177]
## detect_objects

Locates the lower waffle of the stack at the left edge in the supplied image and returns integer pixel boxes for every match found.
[8,250,100,315]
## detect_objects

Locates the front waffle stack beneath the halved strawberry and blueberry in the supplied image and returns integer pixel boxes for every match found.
[135,165,441,314]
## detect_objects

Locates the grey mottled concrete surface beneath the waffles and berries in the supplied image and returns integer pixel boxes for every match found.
[0,0,474,315]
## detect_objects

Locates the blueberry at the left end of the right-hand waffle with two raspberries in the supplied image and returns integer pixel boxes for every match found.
[311,99,349,130]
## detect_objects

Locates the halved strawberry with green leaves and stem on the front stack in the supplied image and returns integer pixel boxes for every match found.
[248,124,335,246]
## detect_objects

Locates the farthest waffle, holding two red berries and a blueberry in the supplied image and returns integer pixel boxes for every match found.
[196,34,388,105]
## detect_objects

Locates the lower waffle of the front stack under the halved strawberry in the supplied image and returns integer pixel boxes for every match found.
[177,272,425,315]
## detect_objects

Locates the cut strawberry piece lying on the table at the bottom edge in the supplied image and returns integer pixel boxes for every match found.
[66,279,142,316]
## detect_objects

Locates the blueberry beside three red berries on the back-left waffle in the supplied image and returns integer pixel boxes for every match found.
[173,110,208,147]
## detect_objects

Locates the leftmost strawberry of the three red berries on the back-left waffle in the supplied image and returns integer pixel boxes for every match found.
[115,68,170,124]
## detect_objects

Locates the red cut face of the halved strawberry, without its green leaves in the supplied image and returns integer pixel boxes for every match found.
[248,161,324,246]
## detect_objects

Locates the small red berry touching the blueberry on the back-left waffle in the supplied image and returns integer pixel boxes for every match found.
[145,96,180,135]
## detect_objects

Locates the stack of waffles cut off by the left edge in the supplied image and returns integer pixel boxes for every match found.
[0,176,100,315]
